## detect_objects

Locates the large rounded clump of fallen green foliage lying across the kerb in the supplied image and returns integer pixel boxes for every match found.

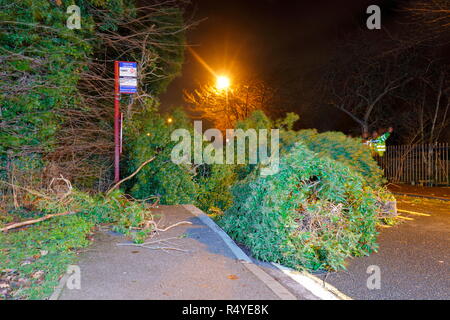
[220,143,378,270]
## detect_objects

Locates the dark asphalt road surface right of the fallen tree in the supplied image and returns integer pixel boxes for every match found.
[318,197,450,300]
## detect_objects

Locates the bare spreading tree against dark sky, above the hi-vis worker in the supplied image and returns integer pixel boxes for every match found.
[322,35,413,132]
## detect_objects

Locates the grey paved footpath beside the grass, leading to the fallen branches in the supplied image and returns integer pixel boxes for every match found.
[59,206,295,300]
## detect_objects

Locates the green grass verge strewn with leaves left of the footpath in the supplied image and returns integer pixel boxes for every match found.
[0,213,94,300]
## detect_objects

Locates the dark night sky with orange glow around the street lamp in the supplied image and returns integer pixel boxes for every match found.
[161,0,412,131]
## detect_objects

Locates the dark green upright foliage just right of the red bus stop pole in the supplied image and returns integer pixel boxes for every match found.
[127,108,196,204]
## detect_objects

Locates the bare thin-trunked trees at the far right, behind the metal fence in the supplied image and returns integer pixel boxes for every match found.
[395,0,450,145]
